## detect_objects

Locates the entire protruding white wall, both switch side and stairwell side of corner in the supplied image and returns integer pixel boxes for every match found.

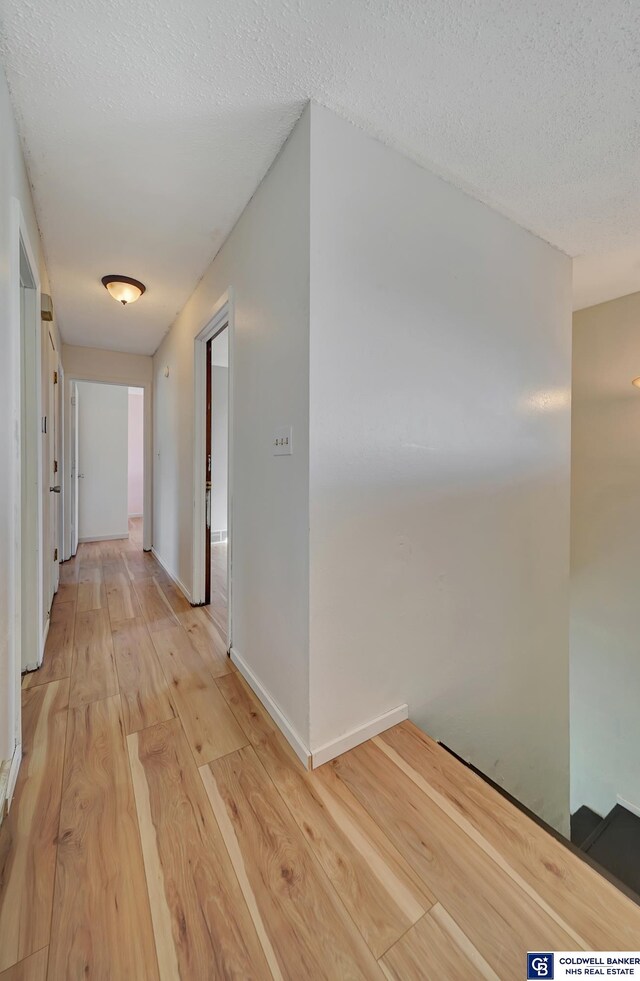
[154,106,571,831]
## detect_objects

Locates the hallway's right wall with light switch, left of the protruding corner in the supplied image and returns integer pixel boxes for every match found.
[154,112,309,741]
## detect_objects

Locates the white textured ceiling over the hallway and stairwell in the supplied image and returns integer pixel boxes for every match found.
[0,0,640,353]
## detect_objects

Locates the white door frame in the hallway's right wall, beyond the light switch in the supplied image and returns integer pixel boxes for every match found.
[191,287,235,650]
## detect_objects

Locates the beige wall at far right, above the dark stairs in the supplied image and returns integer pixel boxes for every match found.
[571,293,640,815]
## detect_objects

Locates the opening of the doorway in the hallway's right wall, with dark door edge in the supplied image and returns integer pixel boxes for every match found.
[205,325,229,640]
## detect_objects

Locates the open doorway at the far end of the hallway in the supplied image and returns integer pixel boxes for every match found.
[69,381,144,554]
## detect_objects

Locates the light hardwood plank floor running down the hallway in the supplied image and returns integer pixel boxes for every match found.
[0,526,640,981]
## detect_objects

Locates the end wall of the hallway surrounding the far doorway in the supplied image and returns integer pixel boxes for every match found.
[62,344,153,554]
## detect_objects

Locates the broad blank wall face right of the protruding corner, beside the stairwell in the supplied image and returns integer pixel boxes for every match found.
[310,106,571,832]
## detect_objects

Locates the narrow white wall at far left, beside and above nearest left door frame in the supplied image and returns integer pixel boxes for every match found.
[0,59,49,765]
